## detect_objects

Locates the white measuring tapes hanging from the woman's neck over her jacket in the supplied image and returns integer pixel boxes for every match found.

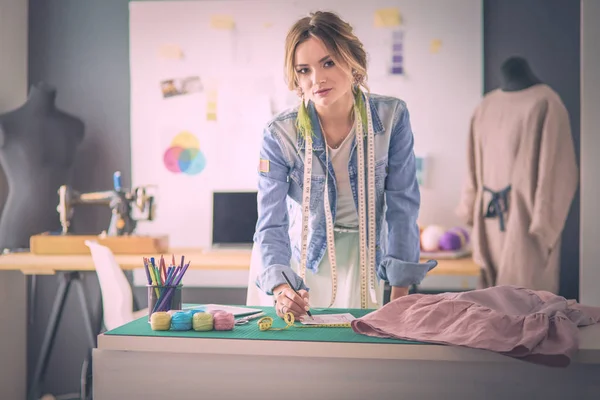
[299,89,377,309]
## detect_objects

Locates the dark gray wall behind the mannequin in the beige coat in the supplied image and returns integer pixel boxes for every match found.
[483,0,581,299]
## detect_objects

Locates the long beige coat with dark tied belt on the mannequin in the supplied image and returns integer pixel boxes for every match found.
[457,84,578,293]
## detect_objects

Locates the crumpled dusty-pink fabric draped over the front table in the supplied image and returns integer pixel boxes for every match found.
[352,286,600,367]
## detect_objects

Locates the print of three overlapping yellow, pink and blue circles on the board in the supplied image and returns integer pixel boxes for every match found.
[163,131,206,175]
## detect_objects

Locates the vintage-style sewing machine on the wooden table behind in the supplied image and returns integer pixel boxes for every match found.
[56,171,155,236]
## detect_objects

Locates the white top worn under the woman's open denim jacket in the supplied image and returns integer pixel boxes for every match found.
[327,128,358,227]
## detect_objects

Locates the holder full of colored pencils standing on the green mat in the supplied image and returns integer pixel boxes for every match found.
[144,256,190,321]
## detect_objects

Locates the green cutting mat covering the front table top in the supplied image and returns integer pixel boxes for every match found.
[105,305,425,344]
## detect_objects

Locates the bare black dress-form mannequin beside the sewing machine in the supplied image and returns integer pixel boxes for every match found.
[0,83,84,249]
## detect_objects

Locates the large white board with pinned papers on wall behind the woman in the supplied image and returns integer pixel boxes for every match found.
[129,0,483,247]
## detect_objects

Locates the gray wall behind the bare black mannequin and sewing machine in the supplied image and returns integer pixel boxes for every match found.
[28,0,130,394]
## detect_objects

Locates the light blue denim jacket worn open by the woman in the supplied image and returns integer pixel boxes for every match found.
[254,94,437,295]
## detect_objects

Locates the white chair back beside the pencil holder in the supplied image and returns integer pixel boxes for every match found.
[85,240,148,330]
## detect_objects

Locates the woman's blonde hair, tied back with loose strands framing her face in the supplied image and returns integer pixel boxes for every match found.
[284,11,368,90]
